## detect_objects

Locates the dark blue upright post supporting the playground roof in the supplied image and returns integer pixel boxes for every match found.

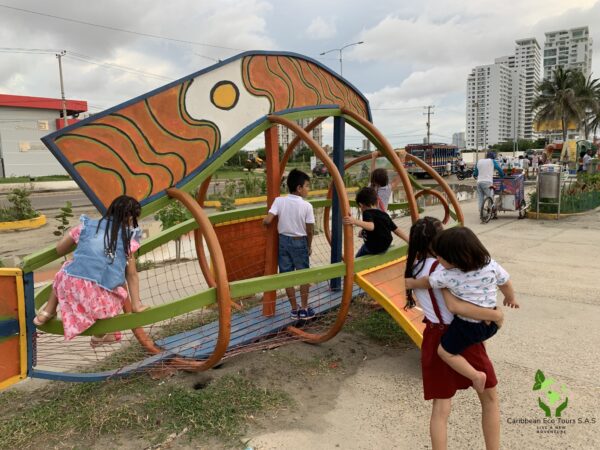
[329,116,346,291]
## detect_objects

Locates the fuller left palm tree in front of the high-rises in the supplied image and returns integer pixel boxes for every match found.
[531,66,585,159]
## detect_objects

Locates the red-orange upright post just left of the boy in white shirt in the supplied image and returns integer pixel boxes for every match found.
[263,125,281,316]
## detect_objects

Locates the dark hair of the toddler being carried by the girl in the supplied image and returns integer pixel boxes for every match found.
[432,227,491,272]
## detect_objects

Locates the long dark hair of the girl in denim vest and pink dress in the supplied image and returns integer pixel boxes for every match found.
[96,195,142,259]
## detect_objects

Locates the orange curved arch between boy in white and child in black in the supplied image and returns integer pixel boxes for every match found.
[267,115,354,344]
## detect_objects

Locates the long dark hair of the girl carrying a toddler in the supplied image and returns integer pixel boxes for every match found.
[404,216,444,308]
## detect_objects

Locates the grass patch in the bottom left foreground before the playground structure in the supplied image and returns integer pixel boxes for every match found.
[0,376,290,449]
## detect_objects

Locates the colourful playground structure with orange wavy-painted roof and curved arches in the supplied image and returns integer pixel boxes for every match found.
[0,51,463,388]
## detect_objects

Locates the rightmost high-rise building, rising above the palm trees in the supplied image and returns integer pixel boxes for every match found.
[544,27,593,79]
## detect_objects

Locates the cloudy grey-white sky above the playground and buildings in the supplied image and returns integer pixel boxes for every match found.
[0,0,600,147]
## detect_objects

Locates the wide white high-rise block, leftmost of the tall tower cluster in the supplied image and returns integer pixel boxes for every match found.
[466,60,525,149]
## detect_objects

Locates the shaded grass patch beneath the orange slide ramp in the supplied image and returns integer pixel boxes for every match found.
[344,297,412,347]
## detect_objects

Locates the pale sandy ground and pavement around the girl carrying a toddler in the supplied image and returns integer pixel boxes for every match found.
[2,188,600,450]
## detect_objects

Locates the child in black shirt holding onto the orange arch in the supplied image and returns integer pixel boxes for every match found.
[343,187,408,258]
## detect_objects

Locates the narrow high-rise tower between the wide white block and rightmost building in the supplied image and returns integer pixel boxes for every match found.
[514,38,542,140]
